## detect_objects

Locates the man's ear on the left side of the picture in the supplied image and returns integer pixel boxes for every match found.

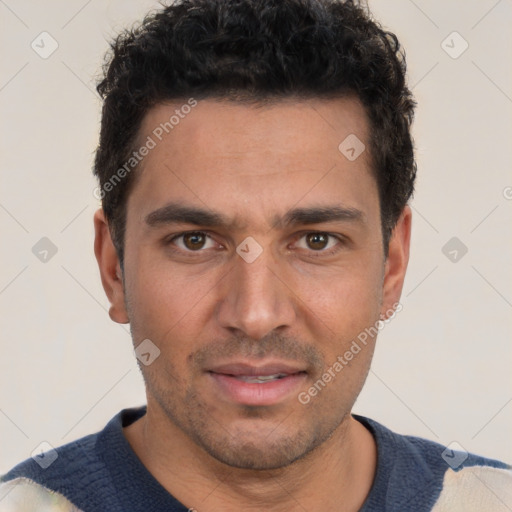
[94,208,130,324]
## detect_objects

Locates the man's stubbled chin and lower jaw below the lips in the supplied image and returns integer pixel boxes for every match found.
[146,374,345,471]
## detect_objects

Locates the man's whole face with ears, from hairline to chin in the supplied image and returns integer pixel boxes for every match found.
[96,98,410,469]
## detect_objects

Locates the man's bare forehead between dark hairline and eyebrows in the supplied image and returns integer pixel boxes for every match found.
[128,98,378,230]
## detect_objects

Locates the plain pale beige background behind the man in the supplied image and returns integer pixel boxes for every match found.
[0,0,512,472]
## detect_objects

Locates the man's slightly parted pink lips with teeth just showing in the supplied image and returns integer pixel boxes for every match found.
[207,362,307,406]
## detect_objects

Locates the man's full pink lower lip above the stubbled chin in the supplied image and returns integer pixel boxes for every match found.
[209,372,306,405]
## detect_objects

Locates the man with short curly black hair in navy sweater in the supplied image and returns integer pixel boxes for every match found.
[0,0,512,512]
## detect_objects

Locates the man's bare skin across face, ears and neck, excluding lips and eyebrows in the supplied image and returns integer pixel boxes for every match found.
[95,98,411,512]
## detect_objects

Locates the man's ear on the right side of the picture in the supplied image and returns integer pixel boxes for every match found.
[380,206,412,320]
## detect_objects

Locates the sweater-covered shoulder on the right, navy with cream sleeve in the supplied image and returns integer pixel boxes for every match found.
[355,415,512,512]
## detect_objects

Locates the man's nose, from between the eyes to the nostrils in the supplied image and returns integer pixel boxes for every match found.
[217,246,297,340]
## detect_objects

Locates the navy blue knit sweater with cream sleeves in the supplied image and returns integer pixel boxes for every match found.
[0,407,512,512]
